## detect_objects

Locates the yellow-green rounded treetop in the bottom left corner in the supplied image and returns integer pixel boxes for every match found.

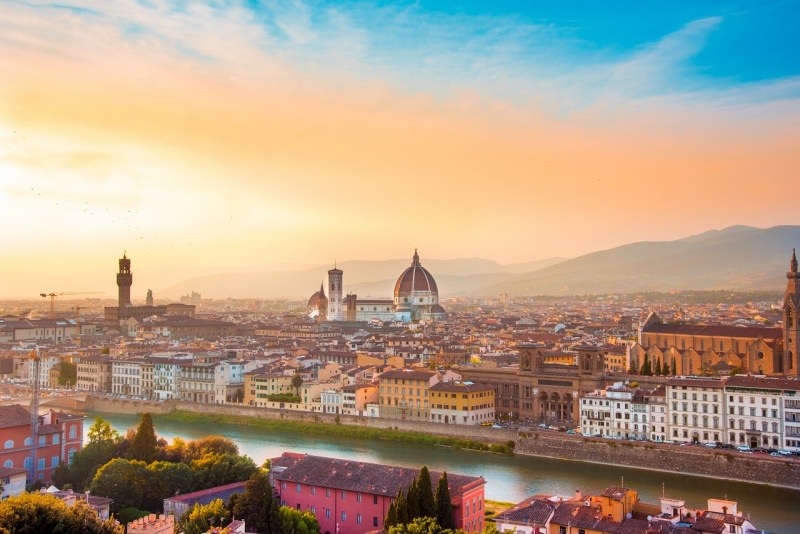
[0,493,125,534]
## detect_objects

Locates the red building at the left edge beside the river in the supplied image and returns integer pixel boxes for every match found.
[0,404,84,481]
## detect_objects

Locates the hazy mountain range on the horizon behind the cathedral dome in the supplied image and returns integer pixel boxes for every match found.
[159,226,800,299]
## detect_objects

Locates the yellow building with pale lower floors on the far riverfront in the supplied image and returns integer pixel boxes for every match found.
[429,382,494,425]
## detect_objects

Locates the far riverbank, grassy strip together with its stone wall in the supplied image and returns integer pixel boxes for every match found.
[79,396,800,490]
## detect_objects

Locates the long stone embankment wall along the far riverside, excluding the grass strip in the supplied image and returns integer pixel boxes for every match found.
[85,396,800,489]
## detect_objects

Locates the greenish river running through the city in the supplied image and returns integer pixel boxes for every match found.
[90,414,800,534]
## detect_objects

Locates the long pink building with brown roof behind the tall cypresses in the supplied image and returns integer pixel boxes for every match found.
[270,452,485,534]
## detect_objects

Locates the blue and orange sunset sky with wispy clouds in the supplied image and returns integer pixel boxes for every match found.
[0,0,800,298]
